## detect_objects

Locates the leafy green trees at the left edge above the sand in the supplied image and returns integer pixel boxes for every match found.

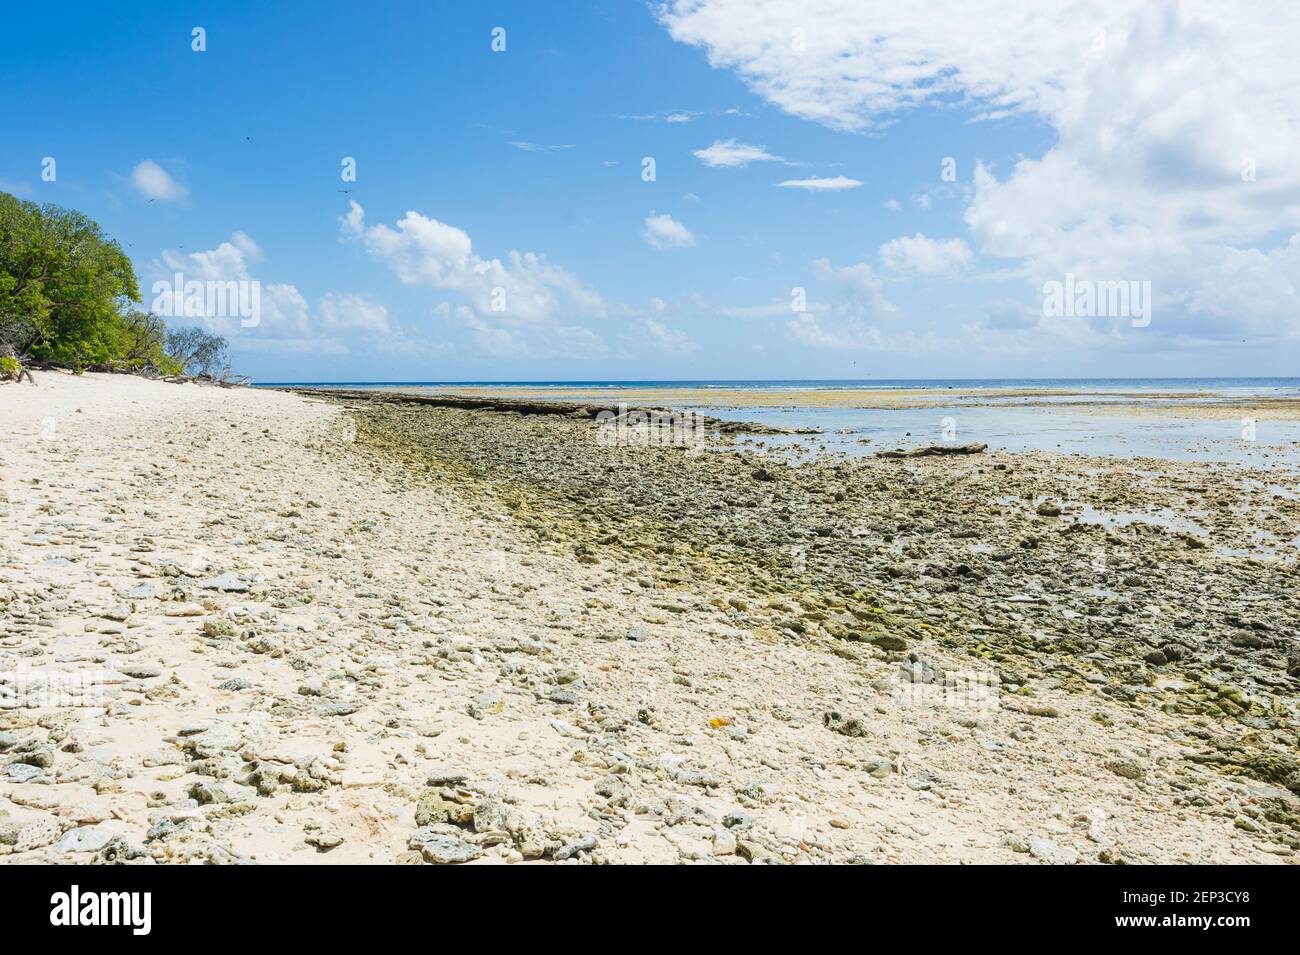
[0,192,191,374]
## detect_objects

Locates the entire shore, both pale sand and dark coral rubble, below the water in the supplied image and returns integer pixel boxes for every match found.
[0,374,1297,865]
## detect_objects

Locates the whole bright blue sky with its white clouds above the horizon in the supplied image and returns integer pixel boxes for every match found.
[0,0,1300,381]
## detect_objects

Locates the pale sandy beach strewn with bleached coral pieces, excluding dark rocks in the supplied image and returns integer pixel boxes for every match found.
[0,373,1294,864]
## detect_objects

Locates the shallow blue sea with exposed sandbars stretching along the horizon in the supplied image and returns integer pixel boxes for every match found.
[250,378,1300,474]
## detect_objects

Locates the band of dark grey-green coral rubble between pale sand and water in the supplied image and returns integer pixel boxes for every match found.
[340,394,1300,847]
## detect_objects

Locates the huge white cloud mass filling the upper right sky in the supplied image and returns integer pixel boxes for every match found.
[658,0,1300,342]
